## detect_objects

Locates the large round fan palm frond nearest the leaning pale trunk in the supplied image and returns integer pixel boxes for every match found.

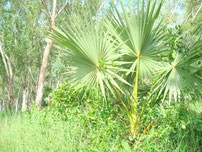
[50,14,130,98]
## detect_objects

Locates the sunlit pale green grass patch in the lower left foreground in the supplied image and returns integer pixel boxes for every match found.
[0,111,124,152]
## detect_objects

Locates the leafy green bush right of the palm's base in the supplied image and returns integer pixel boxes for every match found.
[134,103,202,152]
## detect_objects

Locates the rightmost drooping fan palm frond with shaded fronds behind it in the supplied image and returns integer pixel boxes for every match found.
[158,27,202,103]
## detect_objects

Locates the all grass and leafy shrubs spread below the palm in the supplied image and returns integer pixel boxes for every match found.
[0,84,202,152]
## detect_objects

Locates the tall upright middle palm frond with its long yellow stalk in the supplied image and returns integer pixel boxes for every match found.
[106,0,164,132]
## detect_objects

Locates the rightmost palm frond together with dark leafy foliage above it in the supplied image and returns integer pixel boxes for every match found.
[159,26,202,102]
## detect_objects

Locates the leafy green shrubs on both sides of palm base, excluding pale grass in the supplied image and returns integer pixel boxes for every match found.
[42,84,202,151]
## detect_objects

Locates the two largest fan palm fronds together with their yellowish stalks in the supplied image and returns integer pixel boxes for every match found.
[50,0,166,134]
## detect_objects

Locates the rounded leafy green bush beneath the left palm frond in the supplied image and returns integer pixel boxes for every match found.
[49,83,117,121]
